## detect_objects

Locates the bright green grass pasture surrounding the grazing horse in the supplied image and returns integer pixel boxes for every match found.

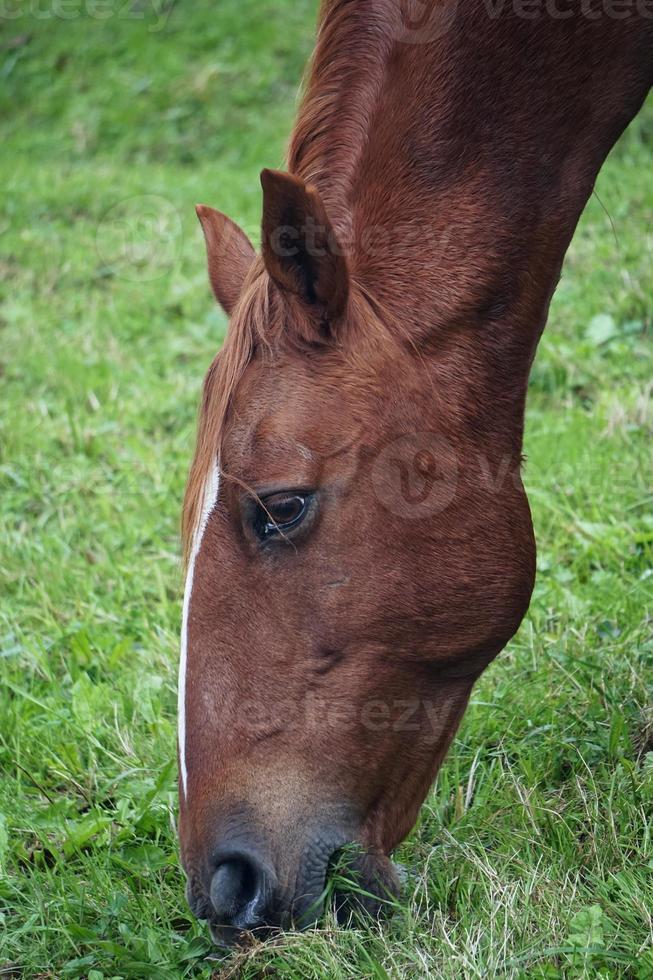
[0,0,653,980]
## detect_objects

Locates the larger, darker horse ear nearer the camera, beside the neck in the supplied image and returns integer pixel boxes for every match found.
[261,170,349,320]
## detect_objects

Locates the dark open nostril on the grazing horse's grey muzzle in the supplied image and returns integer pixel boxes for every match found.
[210,855,265,929]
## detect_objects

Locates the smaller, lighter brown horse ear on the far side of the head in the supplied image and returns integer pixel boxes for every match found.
[195,204,256,316]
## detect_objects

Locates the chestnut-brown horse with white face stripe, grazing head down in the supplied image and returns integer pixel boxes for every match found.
[179,0,653,941]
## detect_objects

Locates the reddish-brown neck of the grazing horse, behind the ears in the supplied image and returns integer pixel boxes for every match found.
[289,0,653,440]
